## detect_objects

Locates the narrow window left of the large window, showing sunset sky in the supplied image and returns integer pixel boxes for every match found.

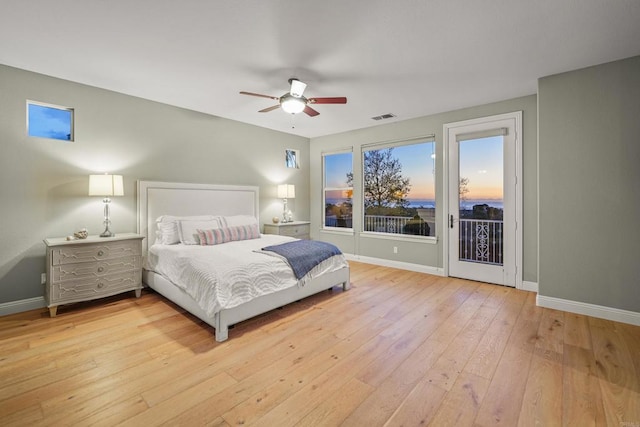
[322,151,353,228]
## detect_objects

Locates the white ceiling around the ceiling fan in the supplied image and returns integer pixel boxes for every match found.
[0,0,640,138]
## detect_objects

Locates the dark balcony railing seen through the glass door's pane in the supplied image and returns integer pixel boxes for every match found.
[459,219,503,265]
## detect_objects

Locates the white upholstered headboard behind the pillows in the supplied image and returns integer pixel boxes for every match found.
[138,181,260,256]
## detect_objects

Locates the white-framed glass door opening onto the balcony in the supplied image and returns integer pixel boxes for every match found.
[447,114,516,286]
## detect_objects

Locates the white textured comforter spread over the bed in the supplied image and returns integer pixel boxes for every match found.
[145,235,348,316]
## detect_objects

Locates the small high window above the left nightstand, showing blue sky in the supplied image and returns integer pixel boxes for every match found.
[27,101,73,141]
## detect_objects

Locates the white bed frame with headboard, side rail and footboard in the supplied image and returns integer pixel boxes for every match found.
[138,181,351,342]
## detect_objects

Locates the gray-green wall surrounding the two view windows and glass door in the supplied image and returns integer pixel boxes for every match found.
[310,95,538,282]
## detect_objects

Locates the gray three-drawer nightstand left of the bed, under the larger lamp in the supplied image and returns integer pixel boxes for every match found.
[44,233,144,317]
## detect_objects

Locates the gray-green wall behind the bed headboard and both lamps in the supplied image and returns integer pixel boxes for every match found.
[0,65,309,303]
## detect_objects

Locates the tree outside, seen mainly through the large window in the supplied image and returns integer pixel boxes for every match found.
[347,148,411,212]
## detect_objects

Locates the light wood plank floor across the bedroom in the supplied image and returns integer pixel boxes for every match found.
[0,263,640,427]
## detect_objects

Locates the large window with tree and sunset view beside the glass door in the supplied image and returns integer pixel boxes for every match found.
[362,137,436,236]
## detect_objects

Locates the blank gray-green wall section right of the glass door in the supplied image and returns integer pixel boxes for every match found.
[538,56,640,312]
